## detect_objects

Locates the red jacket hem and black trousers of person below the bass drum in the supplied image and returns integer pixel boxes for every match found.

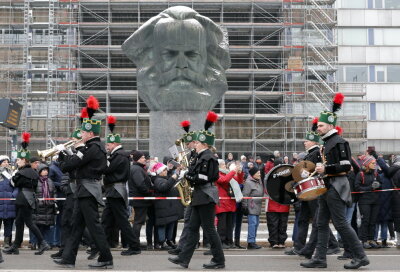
[265,199,290,248]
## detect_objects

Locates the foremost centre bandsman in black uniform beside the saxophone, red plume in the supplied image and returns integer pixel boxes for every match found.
[168,112,225,269]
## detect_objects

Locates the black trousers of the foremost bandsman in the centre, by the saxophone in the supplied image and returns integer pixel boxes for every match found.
[179,203,225,264]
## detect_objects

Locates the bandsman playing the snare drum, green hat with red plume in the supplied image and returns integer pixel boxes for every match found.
[300,93,369,269]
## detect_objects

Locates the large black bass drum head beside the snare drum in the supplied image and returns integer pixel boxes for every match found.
[264,164,297,205]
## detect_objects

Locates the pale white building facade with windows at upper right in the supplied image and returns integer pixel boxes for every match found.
[336,0,400,154]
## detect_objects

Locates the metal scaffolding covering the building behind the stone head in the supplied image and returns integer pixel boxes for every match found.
[0,0,366,157]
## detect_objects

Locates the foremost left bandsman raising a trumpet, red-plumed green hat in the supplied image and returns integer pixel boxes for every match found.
[54,96,113,268]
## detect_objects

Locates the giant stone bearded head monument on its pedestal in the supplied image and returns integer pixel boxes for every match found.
[122,6,230,158]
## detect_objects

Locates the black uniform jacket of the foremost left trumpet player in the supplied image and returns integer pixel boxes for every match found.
[56,137,107,197]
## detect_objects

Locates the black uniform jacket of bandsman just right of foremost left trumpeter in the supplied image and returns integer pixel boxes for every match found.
[104,146,130,197]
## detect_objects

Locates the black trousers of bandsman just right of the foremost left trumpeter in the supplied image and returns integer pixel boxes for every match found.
[102,197,135,247]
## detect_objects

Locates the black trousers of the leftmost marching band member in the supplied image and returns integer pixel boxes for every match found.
[14,205,43,248]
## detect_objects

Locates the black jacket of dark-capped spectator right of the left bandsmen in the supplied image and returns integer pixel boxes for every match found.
[128,161,154,207]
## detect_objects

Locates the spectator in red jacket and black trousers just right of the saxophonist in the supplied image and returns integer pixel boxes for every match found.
[215,160,244,249]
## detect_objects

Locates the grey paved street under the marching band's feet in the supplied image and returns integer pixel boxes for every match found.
[0,248,400,272]
